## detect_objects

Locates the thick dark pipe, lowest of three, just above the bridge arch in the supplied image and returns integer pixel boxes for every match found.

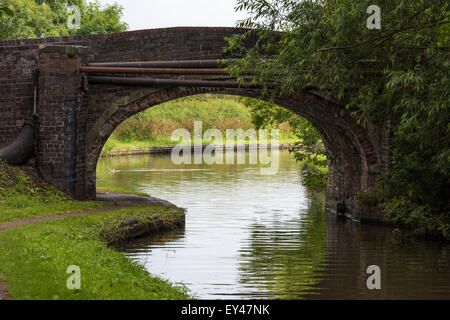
[89,77,263,88]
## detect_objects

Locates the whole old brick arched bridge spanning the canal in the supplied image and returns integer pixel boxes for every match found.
[0,28,388,220]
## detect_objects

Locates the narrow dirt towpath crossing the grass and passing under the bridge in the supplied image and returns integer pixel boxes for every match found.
[0,192,171,301]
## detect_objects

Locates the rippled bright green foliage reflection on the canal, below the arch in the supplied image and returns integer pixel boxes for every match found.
[239,193,326,299]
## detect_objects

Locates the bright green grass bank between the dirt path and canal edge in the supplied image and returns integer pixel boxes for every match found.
[0,205,189,300]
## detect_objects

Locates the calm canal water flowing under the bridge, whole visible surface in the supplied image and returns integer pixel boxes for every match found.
[97,151,450,299]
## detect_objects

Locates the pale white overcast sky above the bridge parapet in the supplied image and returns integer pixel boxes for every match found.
[96,0,250,30]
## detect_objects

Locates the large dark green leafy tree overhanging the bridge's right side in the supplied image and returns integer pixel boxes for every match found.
[228,0,450,238]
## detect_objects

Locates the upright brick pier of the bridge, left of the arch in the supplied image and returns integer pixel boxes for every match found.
[36,45,88,200]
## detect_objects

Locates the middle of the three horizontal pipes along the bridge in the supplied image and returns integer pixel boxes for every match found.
[80,67,229,75]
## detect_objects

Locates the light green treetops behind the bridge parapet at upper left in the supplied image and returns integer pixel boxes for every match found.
[0,0,128,40]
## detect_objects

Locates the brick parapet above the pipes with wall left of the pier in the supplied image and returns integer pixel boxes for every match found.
[0,27,244,147]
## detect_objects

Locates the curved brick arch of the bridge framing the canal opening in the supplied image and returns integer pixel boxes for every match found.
[86,85,379,214]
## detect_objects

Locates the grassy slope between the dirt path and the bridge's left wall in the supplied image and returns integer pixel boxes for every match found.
[0,162,105,224]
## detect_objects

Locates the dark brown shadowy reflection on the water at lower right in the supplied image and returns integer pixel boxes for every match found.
[309,215,450,299]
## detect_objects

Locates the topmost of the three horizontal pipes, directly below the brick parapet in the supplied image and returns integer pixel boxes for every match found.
[88,59,233,68]
